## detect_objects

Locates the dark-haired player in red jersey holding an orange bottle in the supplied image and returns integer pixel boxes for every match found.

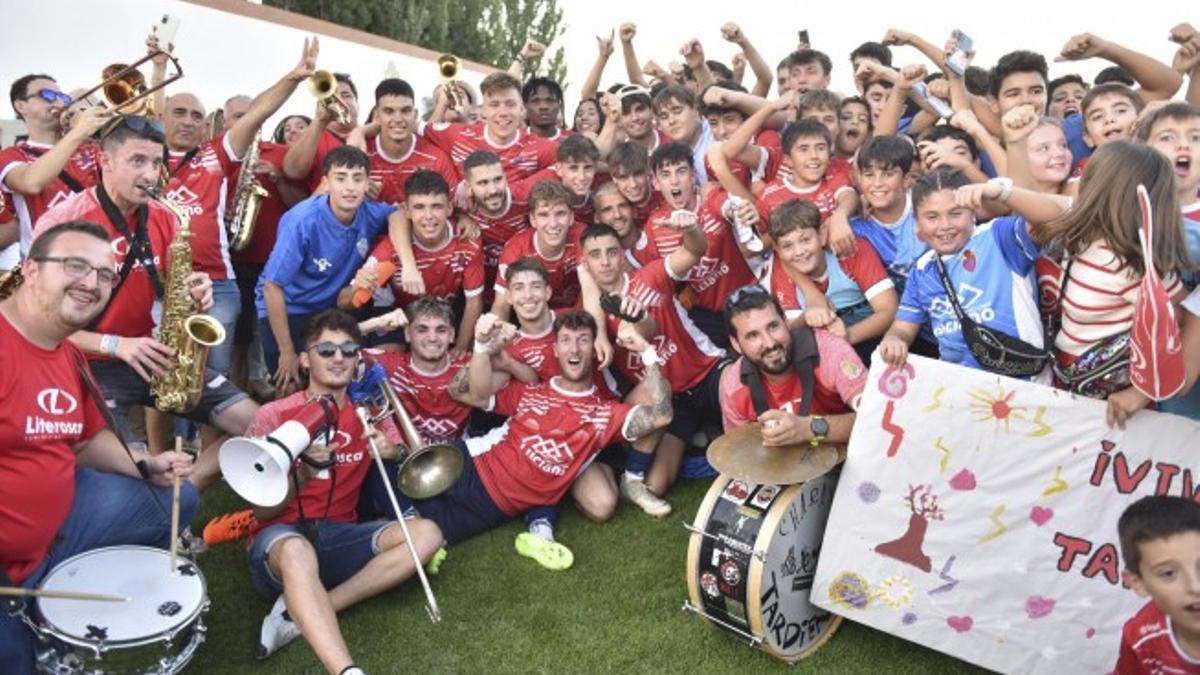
[348,169,484,353]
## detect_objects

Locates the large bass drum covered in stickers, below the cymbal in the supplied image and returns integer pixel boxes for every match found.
[684,474,841,663]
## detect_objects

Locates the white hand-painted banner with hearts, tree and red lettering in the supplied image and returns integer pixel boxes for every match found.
[812,357,1200,674]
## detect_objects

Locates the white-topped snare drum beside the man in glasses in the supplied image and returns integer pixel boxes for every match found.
[31,546,209,675]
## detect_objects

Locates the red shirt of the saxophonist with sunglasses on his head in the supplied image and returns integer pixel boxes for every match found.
[34,187,176,338]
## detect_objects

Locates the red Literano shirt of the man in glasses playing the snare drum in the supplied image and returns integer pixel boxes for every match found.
[0,315,104,584]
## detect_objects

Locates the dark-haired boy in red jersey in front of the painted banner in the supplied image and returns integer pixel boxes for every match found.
[1114,496,1200,675]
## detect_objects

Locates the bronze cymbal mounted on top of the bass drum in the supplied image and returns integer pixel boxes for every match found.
[707,422,846,485]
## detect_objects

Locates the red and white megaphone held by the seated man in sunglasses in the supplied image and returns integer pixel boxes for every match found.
[218,396,338,507]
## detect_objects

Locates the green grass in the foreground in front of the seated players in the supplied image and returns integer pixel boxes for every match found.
[190,482,982,675]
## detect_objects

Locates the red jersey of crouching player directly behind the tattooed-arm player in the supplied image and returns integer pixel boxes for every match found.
[605,259,725,394]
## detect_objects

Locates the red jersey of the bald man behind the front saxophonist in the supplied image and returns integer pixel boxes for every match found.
[164,135,241,280]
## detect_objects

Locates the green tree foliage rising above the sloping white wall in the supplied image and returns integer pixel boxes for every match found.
[265,0,566,85]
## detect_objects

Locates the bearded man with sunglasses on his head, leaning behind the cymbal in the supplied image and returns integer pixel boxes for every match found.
[720,285,866,446]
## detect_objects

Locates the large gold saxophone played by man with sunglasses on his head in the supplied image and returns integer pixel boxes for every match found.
[146,189,226,413]
